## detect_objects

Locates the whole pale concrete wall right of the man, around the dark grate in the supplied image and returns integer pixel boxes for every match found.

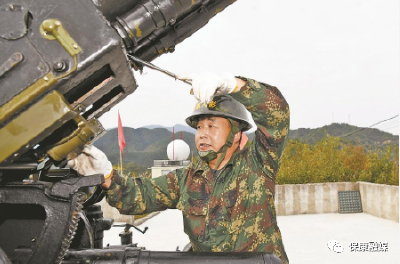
[275,182,399,222]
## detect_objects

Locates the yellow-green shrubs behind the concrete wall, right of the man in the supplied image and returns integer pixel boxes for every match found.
[277,135,399,185]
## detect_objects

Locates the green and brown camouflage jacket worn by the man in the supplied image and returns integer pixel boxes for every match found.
[107,78,289,263]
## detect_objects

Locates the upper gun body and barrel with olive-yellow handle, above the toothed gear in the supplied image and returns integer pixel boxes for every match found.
[0,0,238,166]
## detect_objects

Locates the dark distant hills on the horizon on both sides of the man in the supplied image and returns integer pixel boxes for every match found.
[94,123,399,167]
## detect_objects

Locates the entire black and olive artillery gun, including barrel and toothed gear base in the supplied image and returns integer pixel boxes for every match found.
[0,0,282,264]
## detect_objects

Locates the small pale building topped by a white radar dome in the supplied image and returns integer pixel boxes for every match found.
[151,139,190,178]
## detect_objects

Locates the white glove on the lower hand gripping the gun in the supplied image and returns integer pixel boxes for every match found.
[67,145,113,178]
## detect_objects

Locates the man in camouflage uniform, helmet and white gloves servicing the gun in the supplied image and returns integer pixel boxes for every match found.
[69,73,289,263]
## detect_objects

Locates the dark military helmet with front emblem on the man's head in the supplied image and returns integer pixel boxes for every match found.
[186,95,252,131]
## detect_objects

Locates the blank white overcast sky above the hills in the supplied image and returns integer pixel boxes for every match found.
[100,0,400,135]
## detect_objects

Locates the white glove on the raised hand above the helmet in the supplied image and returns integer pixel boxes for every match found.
[177,72,237,104]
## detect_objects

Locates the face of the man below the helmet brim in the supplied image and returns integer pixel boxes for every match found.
[195,116,231,155]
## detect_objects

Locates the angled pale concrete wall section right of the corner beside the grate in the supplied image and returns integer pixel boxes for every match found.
[359,182,399,222]
